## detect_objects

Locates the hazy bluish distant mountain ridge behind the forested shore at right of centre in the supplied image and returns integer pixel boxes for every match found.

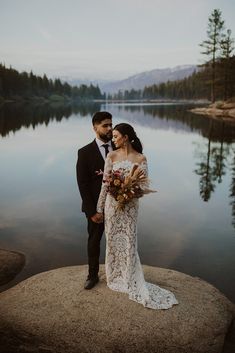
[99,65,198,94]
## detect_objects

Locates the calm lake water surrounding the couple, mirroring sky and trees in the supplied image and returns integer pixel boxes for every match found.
[0,104,235,301]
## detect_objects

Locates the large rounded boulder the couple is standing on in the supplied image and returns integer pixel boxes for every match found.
[0,265,235,353]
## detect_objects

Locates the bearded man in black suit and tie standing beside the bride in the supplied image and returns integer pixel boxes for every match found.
[77,112,113,289]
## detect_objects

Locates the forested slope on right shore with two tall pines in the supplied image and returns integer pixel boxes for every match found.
[108,9,235,102]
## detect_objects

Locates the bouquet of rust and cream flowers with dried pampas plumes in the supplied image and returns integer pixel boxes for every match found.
[103,165,156,210]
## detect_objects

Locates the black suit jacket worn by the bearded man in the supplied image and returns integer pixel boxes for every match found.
[77,140,113,217]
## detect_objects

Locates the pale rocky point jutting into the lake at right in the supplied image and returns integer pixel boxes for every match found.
[190,101,235,122]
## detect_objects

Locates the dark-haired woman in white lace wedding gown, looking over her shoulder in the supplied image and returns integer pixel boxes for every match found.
[97,123,178,309]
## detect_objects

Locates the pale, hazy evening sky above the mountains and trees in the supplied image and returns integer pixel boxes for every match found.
[0,0,235,81]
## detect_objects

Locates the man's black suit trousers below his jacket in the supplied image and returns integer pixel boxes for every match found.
[87,218,104,278]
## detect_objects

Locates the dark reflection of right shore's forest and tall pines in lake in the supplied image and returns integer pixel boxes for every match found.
[109,104,235,227]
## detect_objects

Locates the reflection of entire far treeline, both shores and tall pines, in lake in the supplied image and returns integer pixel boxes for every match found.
[0,103,235,227]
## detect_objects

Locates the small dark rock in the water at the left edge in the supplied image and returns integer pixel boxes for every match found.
[0,249,25,285]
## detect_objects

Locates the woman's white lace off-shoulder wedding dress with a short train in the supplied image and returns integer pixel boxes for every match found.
[97,157,178,309]
